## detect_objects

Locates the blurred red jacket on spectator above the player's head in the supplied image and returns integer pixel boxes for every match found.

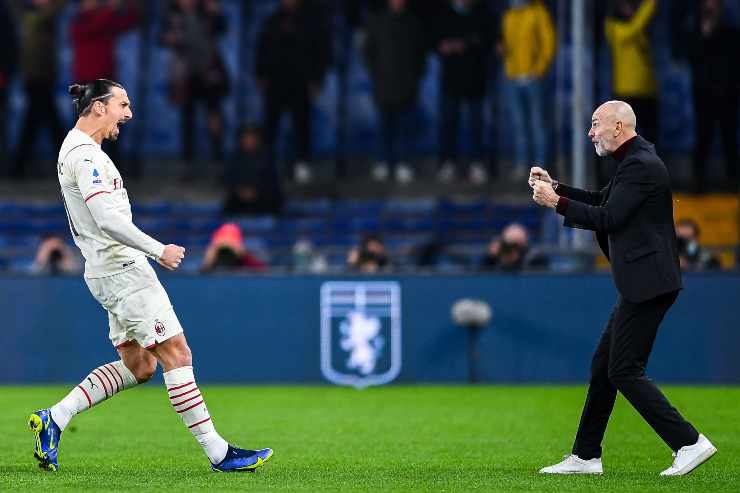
[69,6,139,82]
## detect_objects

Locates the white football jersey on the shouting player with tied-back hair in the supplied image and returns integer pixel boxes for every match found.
[57,128,162,278]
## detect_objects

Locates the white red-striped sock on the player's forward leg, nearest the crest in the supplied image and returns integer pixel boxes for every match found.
[163,366,229,464]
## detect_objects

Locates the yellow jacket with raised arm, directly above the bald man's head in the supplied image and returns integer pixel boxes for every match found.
[604,0,658,97]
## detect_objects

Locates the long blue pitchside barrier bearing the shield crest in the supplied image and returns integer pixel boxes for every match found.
[0,273,740,387]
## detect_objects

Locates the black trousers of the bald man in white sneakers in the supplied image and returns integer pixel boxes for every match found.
[573,291,699,460]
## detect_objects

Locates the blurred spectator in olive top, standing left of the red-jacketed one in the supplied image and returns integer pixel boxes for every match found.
[9,0,67,179]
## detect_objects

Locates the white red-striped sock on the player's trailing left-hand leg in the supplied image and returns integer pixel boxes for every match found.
[51,360,138,431]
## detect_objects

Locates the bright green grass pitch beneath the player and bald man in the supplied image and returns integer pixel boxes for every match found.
[0,382,740,493]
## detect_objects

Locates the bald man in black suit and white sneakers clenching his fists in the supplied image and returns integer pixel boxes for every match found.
[529,101,717,476]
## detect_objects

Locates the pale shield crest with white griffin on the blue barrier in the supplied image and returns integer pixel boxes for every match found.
[321,282,401,387]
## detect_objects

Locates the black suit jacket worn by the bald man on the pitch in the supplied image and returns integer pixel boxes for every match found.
[557,136,682,303]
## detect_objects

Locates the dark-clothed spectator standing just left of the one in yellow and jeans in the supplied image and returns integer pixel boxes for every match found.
[435,0,498,184]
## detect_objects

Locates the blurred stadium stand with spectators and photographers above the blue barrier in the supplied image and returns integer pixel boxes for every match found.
[0,0,740,274]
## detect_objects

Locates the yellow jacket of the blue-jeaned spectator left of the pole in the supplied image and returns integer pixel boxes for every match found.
[501,0,556,79]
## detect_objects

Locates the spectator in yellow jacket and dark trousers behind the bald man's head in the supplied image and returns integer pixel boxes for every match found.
[604,0,658,144]
